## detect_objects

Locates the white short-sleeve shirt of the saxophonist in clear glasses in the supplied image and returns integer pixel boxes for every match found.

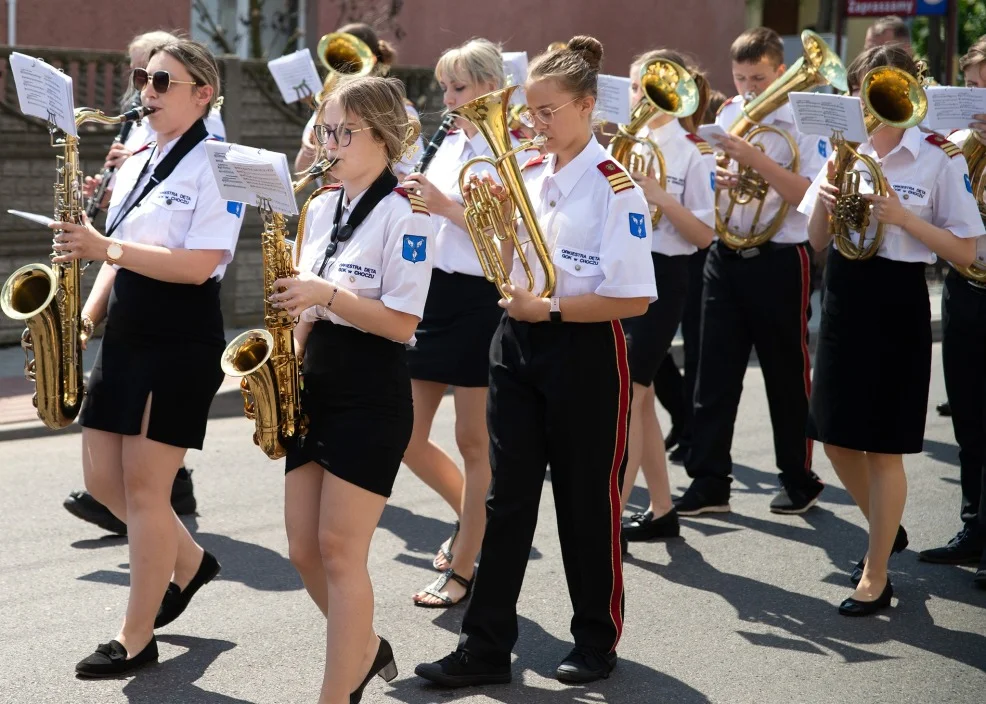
[299,187,434,343]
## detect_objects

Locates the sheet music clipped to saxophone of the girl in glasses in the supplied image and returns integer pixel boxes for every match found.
[205,142,298,215]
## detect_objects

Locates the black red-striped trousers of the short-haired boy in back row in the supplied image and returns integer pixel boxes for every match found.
[685,242,821,498]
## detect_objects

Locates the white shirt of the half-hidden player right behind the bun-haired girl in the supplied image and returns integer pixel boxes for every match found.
[633,120,716,257]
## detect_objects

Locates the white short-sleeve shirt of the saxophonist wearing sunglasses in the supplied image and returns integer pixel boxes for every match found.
[106,137,243,279]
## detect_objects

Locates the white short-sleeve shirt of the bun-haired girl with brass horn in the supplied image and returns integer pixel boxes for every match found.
[510,136,657,302]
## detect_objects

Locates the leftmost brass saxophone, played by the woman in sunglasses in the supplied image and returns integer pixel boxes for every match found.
[0,106,152,430]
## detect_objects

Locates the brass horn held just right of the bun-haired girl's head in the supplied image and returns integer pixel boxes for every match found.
[610,59,699,227]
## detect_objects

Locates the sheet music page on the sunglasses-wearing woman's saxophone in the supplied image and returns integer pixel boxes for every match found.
[10,51,79,137]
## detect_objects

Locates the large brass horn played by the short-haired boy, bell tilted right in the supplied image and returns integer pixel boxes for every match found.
[716,29,846,249]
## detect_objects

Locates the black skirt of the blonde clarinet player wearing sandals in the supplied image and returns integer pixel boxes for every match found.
[407,269,503,387]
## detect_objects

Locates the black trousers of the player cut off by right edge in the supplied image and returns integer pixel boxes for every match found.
[942,270,986,535]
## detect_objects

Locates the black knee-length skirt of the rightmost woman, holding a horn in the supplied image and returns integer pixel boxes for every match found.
[807,248,931,455]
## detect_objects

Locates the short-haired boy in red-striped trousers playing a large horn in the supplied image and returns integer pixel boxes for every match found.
[675,27,829,516]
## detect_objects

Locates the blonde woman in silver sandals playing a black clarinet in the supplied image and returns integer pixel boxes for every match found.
[404,39,524,608]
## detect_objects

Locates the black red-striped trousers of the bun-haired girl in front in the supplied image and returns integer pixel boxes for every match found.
[459,316,630,663]
